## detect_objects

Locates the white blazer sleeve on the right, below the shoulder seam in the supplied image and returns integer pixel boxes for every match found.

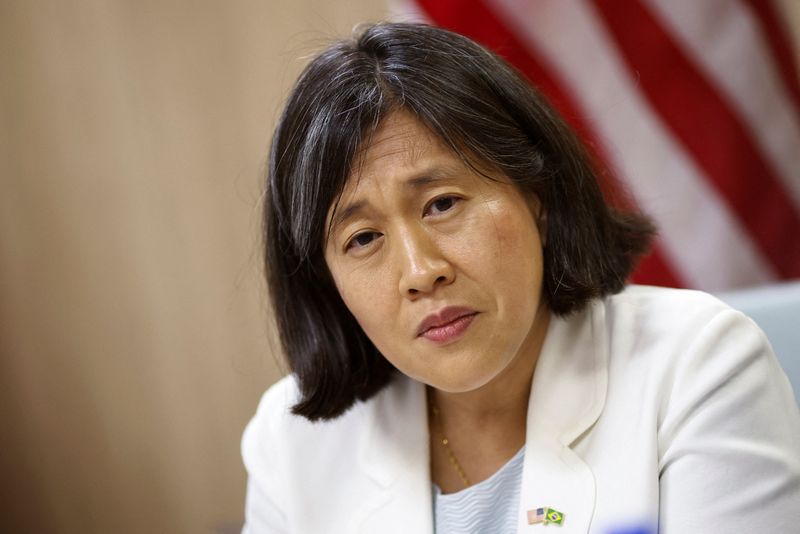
[658,309,800,534]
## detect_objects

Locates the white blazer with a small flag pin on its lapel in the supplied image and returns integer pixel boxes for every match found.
[242,286,800,534]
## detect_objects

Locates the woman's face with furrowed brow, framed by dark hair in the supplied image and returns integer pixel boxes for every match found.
[325,111,548,392]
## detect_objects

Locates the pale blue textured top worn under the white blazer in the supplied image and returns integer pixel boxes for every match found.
[433,447,525,534]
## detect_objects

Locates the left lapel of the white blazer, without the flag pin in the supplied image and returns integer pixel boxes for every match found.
[348,376,433,534]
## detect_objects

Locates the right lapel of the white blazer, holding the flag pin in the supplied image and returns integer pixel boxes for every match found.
[517,301,608,534]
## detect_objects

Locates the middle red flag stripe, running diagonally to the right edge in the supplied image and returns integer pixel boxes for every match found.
[594,0,800,278]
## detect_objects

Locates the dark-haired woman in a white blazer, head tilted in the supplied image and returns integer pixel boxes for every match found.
[242,24,800,534]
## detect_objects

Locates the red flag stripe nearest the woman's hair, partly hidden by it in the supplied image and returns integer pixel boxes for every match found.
[416,0,685,287]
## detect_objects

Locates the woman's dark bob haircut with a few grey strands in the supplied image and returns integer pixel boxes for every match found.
[264,23,653,420]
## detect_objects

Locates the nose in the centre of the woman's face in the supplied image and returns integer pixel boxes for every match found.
[397,229,455,299]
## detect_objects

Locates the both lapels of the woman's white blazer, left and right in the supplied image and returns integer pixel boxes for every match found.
[351,301,608,534]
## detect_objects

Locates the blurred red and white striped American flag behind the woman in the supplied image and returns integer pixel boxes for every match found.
[392,0,800,291]
